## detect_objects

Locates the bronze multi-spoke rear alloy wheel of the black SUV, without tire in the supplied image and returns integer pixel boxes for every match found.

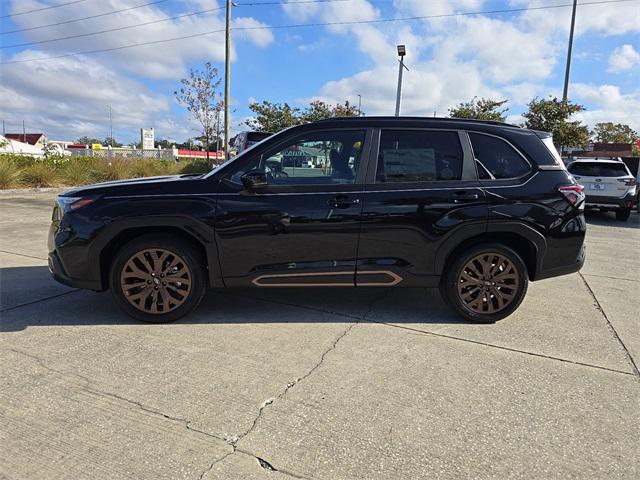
[458,253,520,314]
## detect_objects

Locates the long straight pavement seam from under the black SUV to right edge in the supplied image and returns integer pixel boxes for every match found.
[229,294,636,375]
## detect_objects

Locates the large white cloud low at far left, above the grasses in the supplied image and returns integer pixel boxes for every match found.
[0,51,169,141]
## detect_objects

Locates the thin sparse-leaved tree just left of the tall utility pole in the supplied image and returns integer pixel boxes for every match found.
[173,62,223,165]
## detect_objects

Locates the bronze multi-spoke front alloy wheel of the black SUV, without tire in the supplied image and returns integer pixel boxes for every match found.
[120,248,192,315]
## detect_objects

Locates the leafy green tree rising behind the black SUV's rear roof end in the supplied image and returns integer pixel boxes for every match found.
[522,97,589,151]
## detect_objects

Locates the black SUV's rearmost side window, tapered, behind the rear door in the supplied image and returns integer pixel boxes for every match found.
[469,132,531,180]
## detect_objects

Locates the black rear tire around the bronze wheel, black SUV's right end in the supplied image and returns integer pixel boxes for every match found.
[440,243,529,323]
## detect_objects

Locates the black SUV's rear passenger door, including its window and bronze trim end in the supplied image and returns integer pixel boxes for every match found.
[356,128,487,286]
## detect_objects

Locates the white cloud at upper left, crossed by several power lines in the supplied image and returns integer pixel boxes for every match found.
[6,0,273,78]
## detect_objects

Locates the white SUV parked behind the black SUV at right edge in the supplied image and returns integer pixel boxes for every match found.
[568,160,638,221]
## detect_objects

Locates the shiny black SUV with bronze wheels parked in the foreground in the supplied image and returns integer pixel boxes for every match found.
[49,117,586,322]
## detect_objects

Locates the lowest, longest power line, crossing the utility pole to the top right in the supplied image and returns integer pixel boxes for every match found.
[0,0,639,65]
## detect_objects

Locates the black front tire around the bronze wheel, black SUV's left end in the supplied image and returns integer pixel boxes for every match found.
[109,234,207,323]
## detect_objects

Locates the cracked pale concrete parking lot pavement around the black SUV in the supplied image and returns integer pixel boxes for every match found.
[0,192,640,480]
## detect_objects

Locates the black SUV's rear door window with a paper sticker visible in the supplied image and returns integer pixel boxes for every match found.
[376,130,464,183]
